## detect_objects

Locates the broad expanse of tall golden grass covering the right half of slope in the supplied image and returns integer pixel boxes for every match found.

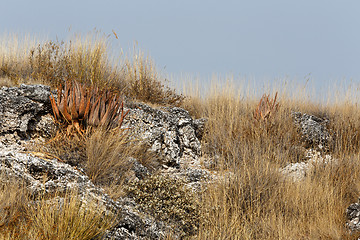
[179,82,360,239]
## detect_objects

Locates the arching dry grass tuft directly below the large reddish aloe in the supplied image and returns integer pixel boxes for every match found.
[84,128,159,199]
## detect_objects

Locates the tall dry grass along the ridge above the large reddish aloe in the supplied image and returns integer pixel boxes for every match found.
[0,32,184,105]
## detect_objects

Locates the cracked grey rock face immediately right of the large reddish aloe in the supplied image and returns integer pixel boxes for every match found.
[124,103,205,167]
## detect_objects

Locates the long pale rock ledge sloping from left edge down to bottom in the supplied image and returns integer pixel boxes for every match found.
[0,149,165,239]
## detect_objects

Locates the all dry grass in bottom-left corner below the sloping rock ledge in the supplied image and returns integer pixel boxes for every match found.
[0,174,116,240]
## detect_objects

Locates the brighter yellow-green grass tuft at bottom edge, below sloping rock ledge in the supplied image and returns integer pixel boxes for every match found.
[28,191,115,240]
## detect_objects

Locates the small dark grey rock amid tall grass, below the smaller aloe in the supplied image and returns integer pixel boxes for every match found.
[292,112,331,152]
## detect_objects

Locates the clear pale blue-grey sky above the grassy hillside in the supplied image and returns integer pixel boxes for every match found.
[0,0,360,99]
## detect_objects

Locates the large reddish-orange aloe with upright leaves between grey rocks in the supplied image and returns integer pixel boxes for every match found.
[50,81,129,134]
